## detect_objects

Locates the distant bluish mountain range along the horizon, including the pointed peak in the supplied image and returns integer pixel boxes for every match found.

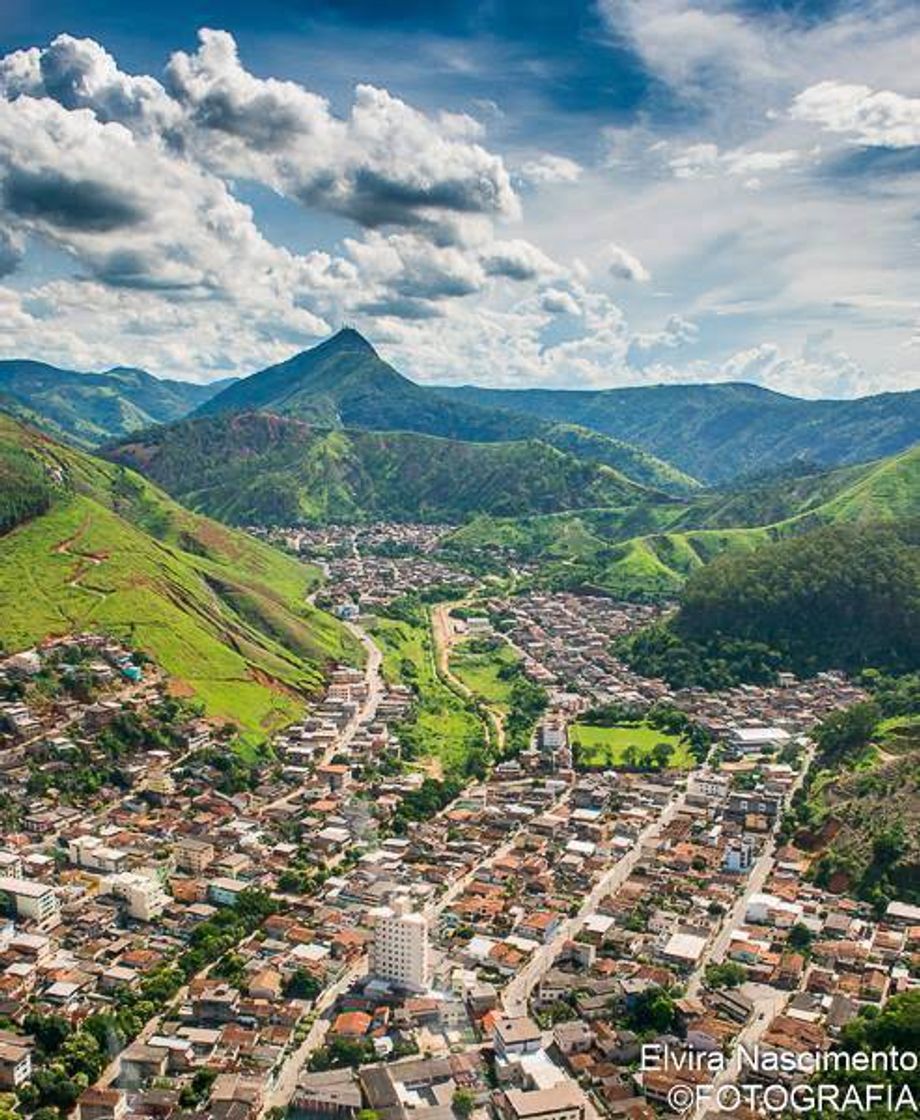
[0,328,920,495]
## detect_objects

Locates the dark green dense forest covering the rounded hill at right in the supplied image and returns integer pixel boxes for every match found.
[620,522,920,688]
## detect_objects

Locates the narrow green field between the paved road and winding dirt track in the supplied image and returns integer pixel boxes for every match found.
[370,617,483,774]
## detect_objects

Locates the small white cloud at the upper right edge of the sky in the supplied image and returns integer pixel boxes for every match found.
[789,82,920,148]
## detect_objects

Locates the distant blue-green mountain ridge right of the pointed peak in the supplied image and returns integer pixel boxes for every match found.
[439,383,920,483]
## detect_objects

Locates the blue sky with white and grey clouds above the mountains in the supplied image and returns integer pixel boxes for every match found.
[0,0,920,396]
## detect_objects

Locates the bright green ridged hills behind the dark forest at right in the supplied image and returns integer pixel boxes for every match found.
[444,445,920,595]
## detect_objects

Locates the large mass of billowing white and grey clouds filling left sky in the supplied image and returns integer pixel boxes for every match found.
[0,30,565,367]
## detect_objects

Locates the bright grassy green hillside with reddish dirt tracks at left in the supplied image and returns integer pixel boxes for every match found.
[0,413,362,734]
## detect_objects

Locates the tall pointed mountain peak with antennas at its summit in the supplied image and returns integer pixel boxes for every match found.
[195,328,699,494]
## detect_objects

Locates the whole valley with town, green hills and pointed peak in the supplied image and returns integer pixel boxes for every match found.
[0,333,920,1120]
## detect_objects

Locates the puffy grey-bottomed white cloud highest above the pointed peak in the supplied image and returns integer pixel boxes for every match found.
[166,30,519,227]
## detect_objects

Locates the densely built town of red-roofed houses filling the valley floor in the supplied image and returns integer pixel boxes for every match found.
[0,526,920,1120]
